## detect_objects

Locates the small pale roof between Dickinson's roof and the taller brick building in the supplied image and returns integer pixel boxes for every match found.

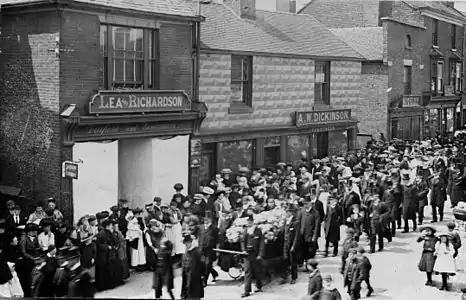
[330,27,383,60]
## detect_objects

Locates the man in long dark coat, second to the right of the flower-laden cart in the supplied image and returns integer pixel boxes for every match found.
[297,199,320,263]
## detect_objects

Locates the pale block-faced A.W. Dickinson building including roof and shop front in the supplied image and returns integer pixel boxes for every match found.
[187,0,367,188]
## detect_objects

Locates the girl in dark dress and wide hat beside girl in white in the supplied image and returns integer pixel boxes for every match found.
[417,226,437,285]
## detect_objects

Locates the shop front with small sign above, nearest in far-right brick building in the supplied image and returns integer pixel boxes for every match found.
[388,96,425,140]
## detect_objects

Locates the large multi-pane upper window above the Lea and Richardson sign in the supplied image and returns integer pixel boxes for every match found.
[100,25,158,90]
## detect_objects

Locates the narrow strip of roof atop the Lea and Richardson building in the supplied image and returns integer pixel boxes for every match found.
[0,0,196,17]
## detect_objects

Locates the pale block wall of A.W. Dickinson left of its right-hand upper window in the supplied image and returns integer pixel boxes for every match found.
[199,54,314,131]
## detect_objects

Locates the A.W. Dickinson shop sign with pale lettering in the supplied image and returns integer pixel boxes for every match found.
[295,109,351,126]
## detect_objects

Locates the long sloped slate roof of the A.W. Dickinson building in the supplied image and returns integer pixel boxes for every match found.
[197,4,363,59]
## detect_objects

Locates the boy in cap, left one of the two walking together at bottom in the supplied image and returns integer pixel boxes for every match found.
[343,248,364,300]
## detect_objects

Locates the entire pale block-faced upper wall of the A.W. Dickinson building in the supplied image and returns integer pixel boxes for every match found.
[199,54,370,132]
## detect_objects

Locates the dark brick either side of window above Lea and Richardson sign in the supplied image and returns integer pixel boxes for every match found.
[60,11,193,114]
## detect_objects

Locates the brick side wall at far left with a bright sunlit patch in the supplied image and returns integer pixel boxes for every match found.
[0,12,61,211]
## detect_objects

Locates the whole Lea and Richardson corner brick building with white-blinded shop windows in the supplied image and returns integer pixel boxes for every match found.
[0,0,205,218]
